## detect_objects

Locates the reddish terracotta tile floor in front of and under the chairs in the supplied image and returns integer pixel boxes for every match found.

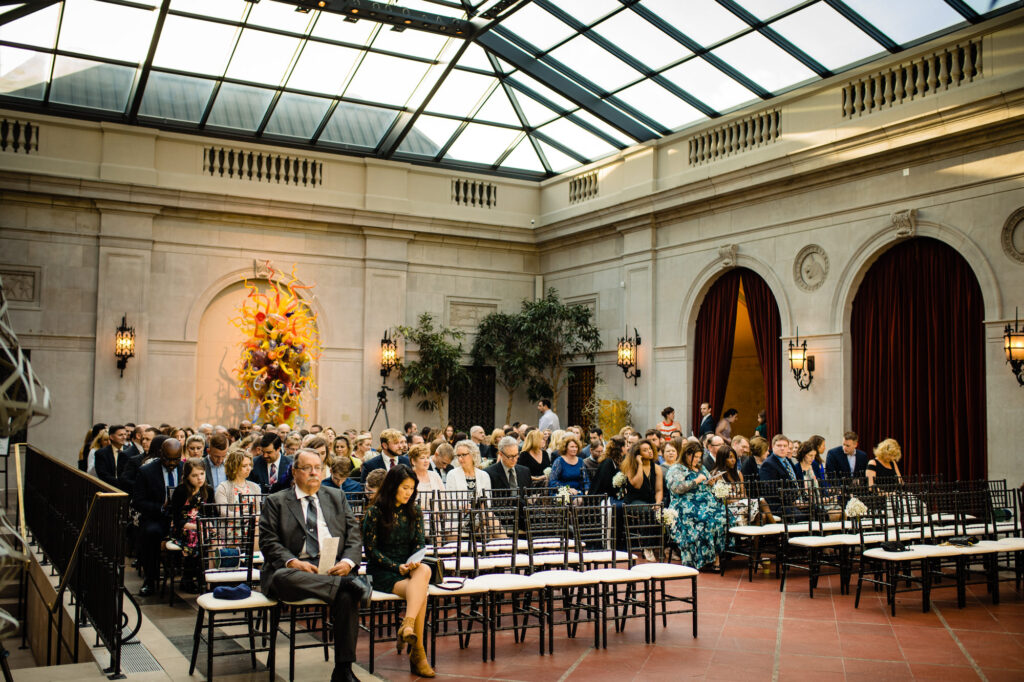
[140,568,1024,682]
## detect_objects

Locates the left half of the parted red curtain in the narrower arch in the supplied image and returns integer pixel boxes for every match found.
[691,269,740,433]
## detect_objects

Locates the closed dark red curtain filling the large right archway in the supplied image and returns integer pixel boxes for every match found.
[851,238,987,480]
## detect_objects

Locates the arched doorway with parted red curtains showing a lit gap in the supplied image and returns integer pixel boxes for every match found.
[691,267,782,436]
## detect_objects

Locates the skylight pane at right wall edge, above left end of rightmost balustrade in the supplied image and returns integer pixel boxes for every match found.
[772,2,885,71]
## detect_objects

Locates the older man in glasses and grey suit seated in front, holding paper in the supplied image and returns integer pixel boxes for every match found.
[259,450,372,682]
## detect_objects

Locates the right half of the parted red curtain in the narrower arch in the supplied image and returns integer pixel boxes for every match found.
[740,269,782,439]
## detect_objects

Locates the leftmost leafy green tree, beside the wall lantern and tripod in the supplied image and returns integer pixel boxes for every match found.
[397,312,469,428]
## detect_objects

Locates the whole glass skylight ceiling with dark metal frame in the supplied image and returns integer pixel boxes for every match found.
[0,0,1011,178]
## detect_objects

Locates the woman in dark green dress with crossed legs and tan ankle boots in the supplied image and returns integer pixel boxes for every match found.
[362,464,434,677]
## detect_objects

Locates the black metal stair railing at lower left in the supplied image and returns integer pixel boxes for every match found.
[24,445,128,678]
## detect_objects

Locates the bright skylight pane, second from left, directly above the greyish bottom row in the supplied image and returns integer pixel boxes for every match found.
[57,0,157,61]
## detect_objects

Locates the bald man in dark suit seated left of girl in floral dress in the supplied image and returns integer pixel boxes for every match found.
[131,438,183,597]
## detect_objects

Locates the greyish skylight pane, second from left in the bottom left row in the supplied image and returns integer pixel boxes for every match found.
[50,57,135,112]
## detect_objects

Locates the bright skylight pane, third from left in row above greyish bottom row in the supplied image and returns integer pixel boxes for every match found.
[153,16,239,76]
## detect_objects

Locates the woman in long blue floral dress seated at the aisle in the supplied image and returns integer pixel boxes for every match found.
[666,442,726,569]
